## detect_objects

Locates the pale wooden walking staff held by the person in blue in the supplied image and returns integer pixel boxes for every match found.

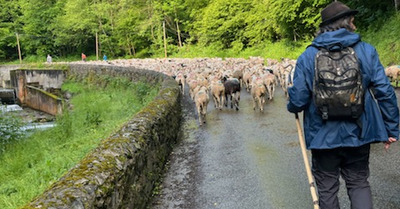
[295,113,319,209]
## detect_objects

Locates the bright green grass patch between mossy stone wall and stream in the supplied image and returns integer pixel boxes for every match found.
[0,79,158,209]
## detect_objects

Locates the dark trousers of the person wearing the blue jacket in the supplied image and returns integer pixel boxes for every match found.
[311,144,372,209]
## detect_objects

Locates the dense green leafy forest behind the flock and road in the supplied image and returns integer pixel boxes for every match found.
[0,0,400,61]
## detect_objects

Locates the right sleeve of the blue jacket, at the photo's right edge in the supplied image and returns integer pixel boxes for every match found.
[371,49,399,139]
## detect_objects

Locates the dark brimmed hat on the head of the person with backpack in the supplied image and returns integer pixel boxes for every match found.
[319,1,358,26]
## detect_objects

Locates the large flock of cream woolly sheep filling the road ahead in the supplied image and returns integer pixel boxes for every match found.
[74,57,400,125]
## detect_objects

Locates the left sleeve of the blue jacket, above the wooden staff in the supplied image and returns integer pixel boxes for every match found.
[287,54,312,113]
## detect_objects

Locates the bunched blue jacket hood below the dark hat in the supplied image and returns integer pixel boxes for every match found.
[312,28,361,48]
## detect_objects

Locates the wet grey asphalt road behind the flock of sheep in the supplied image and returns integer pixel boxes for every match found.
[149,87,400,209]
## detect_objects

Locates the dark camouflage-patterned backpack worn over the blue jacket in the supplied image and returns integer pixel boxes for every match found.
[313,47,365,120]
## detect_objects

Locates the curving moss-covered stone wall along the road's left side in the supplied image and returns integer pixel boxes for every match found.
[23,65,181,209]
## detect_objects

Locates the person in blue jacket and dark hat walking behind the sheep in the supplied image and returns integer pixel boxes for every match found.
[287,1,399,209]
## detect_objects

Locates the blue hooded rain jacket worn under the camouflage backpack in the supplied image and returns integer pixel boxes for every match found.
[287,29,399,149]
